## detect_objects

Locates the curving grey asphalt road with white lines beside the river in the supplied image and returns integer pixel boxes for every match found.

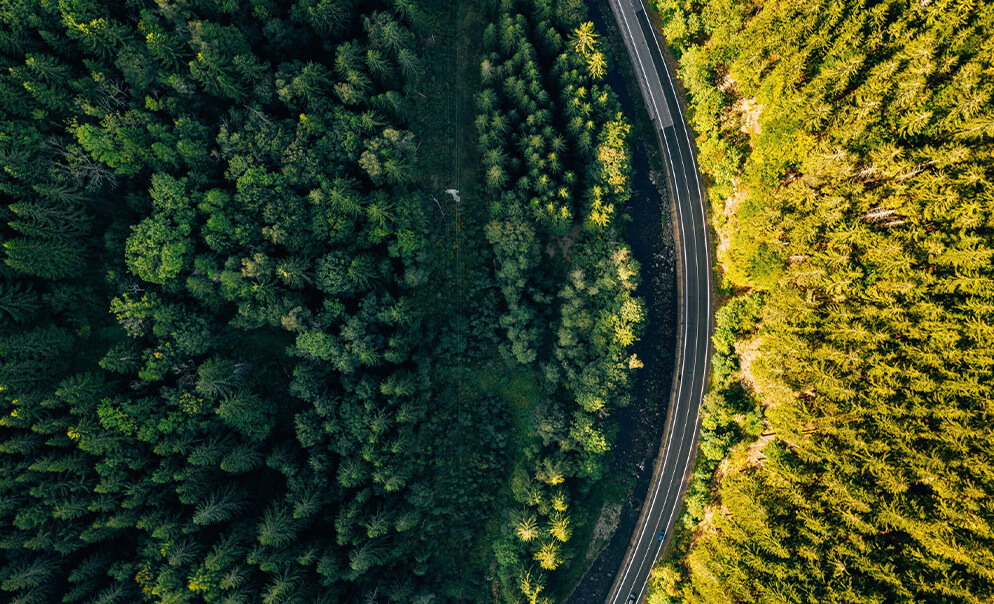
[607,0,713,604]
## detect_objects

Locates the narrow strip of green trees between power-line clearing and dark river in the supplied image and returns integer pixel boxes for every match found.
[477,1,643,602]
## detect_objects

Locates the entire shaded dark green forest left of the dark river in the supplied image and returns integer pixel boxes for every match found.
[0,0,643,604]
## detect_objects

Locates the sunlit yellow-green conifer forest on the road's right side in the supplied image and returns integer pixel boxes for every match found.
[652,0,994,603]
